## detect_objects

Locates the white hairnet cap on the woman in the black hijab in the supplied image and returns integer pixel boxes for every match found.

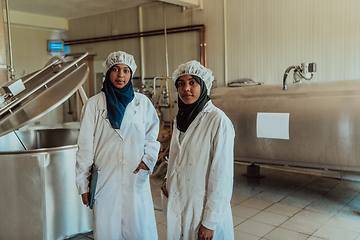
[172,60,214,95]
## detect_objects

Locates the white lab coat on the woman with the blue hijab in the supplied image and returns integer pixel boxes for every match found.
[76,92,160,240]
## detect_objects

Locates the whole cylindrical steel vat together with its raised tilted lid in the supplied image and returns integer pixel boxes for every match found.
[0,53,92,240]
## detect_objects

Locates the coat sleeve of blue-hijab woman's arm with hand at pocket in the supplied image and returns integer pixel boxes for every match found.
[141,100,160,174]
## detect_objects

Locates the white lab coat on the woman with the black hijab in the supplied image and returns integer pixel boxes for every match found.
[162,101,235,240]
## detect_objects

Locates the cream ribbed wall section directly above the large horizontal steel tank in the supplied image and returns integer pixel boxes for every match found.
[226,0,360,84]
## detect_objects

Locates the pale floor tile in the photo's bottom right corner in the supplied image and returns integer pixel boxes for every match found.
[313,225,359,240]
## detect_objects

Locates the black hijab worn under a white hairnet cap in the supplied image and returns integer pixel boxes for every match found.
[175,75,210,132]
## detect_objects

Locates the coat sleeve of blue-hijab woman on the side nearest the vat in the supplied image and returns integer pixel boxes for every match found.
[75,102,95,194]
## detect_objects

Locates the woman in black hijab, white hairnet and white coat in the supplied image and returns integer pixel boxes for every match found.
[161,61,235,240]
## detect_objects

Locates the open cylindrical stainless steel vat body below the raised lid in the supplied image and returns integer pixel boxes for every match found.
[0,129,92,240]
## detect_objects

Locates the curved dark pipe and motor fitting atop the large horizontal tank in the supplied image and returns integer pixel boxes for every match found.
[283,63,316,90]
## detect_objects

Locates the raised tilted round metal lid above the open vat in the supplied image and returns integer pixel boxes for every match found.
[0,53,89,137]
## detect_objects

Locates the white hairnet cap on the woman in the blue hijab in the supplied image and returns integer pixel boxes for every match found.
[103,51,137,76]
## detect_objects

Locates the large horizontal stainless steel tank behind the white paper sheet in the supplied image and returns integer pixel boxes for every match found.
[211,80,360,172]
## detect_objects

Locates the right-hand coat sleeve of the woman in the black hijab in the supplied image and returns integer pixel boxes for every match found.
[202,116,235,226]
